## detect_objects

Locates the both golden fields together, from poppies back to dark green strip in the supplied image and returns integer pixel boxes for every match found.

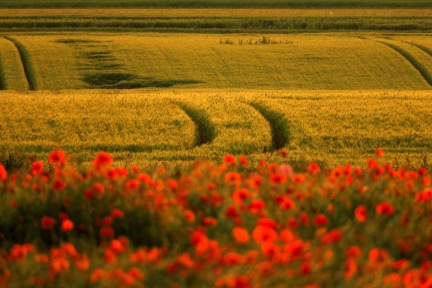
[0,28,432,169]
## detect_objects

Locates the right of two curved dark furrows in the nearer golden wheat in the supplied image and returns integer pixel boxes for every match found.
[248,102,290,150]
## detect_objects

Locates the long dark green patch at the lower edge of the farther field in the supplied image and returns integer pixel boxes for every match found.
[83,73,200,89]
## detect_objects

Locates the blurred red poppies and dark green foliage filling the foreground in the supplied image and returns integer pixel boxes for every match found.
[0,149,432,288]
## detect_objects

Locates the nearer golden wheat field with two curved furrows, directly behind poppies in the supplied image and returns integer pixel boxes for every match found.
[0,89,432,169]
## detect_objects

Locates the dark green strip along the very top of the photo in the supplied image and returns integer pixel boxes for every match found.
[0,0,432,9]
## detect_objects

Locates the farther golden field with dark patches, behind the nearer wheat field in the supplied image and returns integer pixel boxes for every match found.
[0,33,432,91]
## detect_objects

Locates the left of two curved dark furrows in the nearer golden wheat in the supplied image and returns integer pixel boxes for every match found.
[175,102,216,146]
